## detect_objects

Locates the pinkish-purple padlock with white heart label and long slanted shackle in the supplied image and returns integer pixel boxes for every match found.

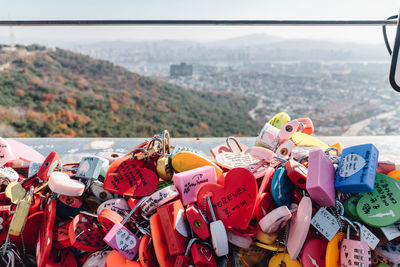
[103,198,145,260]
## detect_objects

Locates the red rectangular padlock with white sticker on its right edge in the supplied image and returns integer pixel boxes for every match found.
[157,199,189,255]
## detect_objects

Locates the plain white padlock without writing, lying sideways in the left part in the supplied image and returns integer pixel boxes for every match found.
[48,172,85,197]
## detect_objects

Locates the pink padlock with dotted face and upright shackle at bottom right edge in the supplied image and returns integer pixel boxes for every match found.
[340,224,371,267]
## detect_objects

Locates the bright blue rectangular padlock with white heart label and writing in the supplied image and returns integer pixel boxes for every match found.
[335,144,379,194]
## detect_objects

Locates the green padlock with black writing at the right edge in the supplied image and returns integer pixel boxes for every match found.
[357,173,400,227]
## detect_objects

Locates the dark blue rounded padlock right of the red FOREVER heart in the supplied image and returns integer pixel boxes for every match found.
[271,168,294,206]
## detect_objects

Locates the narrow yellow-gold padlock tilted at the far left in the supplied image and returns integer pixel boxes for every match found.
[8,186,33,236]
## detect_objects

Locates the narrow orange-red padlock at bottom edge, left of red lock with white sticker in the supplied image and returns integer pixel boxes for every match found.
[150,213,176,267]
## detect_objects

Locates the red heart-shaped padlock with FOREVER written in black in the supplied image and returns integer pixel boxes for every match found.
[197,168,258,229]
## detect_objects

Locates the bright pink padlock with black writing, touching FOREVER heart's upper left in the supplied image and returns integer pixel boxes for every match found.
[174,166,217,206]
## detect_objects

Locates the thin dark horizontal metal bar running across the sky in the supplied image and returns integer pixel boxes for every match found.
[0,20,397,26]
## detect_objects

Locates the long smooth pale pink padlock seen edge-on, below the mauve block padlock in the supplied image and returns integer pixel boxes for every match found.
[287,197,312,260]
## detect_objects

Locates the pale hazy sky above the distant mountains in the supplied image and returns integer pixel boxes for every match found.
[0,0,400,44]
